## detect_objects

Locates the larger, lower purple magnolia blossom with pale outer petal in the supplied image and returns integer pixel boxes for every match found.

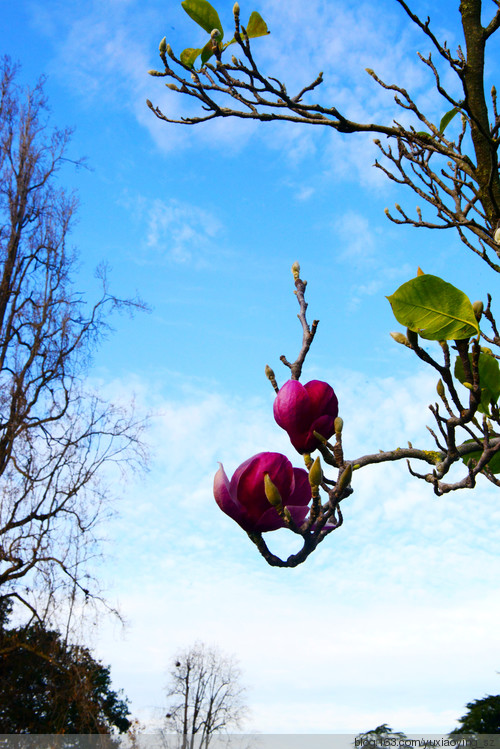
[214,453,311,533]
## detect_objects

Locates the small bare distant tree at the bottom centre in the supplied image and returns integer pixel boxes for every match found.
[165,643,246,749]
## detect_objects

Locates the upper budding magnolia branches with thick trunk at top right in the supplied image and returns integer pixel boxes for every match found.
[147,0,500,272]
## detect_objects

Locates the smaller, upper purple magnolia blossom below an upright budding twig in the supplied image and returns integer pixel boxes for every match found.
[274,380,339,453]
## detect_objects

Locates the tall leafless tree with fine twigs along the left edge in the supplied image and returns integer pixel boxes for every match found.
[0,58,144,620]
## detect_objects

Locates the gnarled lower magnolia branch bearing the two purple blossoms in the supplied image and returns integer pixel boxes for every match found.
[252,263,500,567]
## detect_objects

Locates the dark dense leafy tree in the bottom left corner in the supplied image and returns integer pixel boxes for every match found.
[0,599,131,734]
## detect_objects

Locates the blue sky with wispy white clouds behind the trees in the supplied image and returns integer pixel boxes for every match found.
[0,0,500,732]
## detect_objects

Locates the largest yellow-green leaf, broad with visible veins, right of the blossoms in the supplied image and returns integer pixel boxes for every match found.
[387,273,479,341]
